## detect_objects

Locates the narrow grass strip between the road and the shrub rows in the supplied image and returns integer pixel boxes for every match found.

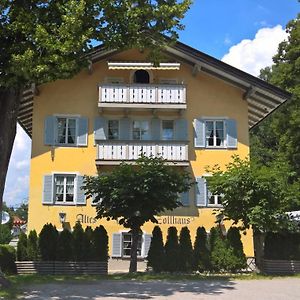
[0,272,300,300]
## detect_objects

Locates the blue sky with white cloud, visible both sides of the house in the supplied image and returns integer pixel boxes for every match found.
[4,0,300,205]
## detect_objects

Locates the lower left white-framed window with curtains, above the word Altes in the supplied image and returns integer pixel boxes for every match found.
[54,175,75,203]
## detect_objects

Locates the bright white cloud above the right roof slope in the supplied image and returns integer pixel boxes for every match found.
[222,25,287,76]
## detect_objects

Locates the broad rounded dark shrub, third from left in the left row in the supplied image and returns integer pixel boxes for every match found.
[39,223,58,261]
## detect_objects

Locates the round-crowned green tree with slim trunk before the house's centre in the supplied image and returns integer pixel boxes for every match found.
[84,156,192,272]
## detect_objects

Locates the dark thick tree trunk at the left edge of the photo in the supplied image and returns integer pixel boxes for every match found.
[0,87,23,224]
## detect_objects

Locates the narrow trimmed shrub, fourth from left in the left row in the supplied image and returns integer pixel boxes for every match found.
[56,229,73,261]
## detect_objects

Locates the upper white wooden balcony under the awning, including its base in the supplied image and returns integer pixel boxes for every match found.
[98,84,186,109]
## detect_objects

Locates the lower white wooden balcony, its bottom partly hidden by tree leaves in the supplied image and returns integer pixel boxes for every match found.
[96,140,189,166]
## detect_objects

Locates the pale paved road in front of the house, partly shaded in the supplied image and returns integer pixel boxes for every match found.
[21,278,300,300]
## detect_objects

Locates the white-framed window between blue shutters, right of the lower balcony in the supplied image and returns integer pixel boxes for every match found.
[205,121,225,147]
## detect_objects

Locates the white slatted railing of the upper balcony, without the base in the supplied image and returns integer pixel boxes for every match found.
[99,84,186,104]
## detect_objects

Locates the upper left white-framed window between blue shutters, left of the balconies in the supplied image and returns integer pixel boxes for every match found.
[57,118,76,145]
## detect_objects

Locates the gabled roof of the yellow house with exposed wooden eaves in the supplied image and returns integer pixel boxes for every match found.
[18,42,291,137]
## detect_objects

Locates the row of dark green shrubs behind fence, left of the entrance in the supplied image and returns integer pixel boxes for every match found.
[17,222,108,261]
